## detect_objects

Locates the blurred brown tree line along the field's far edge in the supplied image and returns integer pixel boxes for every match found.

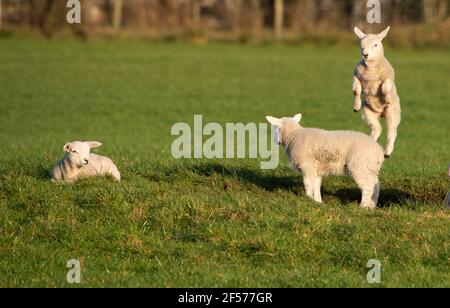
[0,0,450,36]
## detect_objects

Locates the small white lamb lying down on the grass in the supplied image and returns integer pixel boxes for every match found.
[52,141,121,183]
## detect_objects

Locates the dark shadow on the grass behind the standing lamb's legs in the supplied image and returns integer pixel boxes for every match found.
[180,163,416,207]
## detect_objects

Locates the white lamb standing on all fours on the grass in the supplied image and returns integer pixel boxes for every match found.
[266,114,384,209]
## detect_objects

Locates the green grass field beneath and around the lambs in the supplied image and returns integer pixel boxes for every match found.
[0,38,450,287]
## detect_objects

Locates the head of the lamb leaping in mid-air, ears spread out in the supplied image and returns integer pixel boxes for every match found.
[354,27,391,62]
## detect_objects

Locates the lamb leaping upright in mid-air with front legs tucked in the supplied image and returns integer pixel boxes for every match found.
[353,27,401,158]
